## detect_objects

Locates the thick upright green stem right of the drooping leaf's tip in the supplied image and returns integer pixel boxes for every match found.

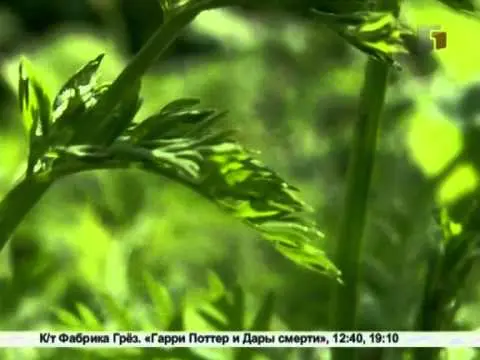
[331,0,399,360]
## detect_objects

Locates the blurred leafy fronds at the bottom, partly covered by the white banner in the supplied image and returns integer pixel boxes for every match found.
[49,272,277,360]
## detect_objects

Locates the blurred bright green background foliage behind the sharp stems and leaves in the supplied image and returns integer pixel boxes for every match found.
[0,0,480,360]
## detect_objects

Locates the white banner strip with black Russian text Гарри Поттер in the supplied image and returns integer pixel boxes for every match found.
[0,331,480,348]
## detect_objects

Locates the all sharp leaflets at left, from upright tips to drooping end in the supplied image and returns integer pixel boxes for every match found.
[10,55,340,278]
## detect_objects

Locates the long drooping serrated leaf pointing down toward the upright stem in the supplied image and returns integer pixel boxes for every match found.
[43,103,340,279]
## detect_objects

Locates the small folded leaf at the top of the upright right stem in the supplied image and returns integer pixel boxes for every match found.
[314,10,412,66]
